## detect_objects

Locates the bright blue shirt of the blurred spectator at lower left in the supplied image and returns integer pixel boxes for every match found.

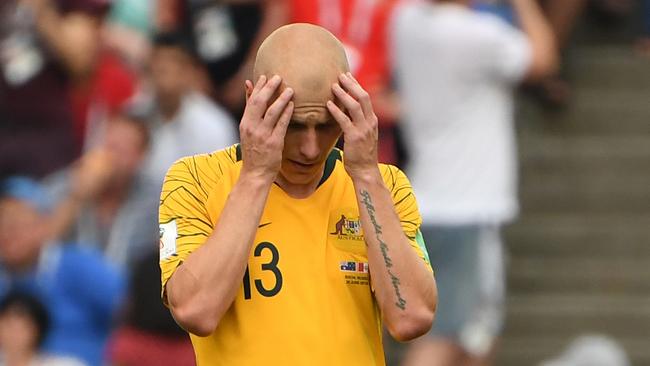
[0,245,126,366]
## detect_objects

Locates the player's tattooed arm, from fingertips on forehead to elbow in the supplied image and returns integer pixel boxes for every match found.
[328,75,437,341]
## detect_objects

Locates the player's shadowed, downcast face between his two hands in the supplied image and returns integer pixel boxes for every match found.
[280,94,341,185]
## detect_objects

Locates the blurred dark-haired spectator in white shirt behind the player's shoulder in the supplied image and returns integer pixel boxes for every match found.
[139,33,237,187]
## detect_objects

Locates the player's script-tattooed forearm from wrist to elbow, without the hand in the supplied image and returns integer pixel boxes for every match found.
[353,171,436,340]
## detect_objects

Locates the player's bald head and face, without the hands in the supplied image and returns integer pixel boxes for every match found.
[247,23,350,192]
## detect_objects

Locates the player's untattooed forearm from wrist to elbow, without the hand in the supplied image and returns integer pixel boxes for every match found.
[167,177,271,335]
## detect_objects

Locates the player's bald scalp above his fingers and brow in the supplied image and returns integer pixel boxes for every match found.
[254,23,349,118]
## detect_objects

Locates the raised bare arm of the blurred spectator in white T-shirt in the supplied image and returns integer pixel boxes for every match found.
[511,0,559,80]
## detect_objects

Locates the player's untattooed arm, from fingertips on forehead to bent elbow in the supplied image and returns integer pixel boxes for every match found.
[166,76,293,336]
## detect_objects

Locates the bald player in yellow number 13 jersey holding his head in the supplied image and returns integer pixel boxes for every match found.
[160,24,437,365]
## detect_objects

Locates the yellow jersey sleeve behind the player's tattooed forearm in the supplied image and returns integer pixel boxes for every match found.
[383,165,431,270]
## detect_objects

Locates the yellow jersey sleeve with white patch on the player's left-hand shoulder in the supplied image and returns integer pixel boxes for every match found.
[158,158,212,304]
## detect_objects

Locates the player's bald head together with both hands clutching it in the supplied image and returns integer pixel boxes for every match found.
[240,24,378,184]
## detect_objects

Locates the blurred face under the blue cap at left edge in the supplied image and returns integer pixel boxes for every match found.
[0,198,47,267]
